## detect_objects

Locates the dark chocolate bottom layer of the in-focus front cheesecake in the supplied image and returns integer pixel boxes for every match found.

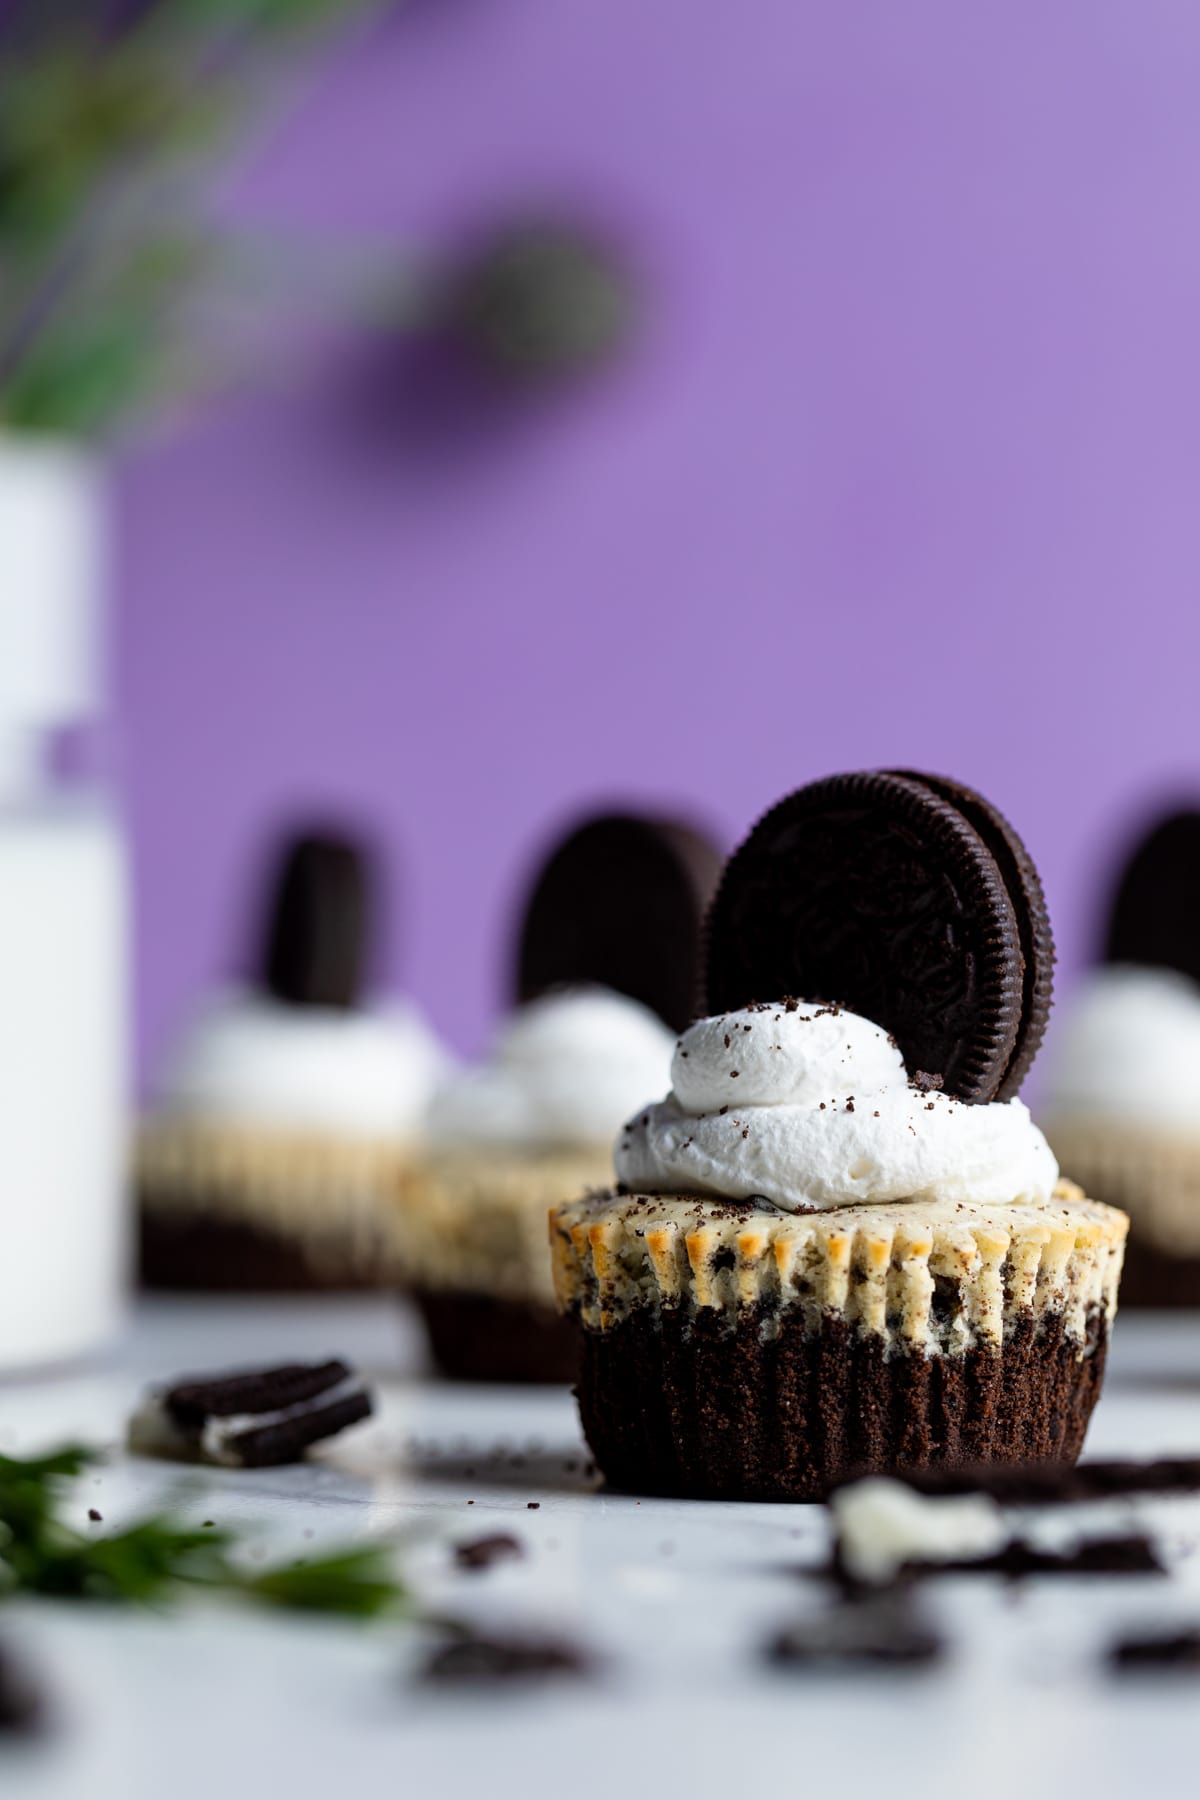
[579,1309,1108,1501]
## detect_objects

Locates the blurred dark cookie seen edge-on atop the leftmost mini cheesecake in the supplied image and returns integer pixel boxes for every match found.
[259,832,371,1012]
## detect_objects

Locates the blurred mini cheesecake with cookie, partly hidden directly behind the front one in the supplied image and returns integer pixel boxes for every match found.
[396,814,720,1381]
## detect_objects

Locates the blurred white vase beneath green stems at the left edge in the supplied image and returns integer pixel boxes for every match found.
[0,434,128,1372]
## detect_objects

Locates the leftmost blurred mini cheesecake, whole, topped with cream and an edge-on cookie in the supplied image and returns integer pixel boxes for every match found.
[137,832,448,1291]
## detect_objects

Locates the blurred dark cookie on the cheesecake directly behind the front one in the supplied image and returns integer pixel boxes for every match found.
[515,812,721,1031]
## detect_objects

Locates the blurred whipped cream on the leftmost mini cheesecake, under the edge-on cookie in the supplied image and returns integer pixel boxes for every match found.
[158,992,450,1139]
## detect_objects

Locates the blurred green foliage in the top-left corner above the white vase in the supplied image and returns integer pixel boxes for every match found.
[0,0,381,436]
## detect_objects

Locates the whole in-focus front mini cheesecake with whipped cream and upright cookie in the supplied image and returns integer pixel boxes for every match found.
[551,770,1128,1499]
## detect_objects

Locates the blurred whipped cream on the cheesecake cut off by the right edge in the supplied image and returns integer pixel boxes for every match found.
[1042,963,1200,1136]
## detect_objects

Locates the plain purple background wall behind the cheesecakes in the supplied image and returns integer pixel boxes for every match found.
[119,0,1200,1060]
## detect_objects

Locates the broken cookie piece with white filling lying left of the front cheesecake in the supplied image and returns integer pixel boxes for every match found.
[130,1361,372,1469]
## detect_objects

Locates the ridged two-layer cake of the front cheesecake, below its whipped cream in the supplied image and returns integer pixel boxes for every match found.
[552,1183,1128,1499]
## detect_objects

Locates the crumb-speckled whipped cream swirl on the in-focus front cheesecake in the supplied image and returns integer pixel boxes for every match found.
[615,1001,1058,1213]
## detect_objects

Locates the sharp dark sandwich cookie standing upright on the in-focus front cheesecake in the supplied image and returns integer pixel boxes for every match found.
[707,770,1052,1103]
